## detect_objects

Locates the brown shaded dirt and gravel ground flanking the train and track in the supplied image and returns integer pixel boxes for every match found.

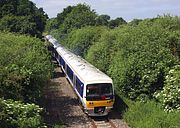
[43,61,127,128]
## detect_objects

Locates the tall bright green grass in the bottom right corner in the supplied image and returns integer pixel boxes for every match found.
[123,101,180,128]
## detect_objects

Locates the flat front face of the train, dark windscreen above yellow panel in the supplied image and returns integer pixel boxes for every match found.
[84,83,114,116]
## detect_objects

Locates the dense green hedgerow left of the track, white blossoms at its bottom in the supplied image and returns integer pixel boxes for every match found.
[0,32,52,128]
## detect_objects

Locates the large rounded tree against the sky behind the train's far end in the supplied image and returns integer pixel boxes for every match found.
[57,4,97,37]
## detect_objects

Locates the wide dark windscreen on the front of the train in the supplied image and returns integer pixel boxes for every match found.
[86,83,113,100]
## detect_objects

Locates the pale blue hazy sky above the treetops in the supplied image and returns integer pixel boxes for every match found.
[31,0,180,21]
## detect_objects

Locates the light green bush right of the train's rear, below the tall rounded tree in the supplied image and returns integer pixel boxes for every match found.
[61,27,106,56]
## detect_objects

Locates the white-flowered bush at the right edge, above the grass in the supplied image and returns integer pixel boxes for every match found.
[155,65,180,111]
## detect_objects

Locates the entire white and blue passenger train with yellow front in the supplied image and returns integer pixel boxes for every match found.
[46,35,114,116]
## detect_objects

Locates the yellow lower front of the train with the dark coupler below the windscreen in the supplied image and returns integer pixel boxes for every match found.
[84,99,114,116]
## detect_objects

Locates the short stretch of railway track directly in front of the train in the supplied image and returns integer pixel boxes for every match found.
[89,117,117,128]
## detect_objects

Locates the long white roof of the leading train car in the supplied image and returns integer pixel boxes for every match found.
[57,46,112,84]
